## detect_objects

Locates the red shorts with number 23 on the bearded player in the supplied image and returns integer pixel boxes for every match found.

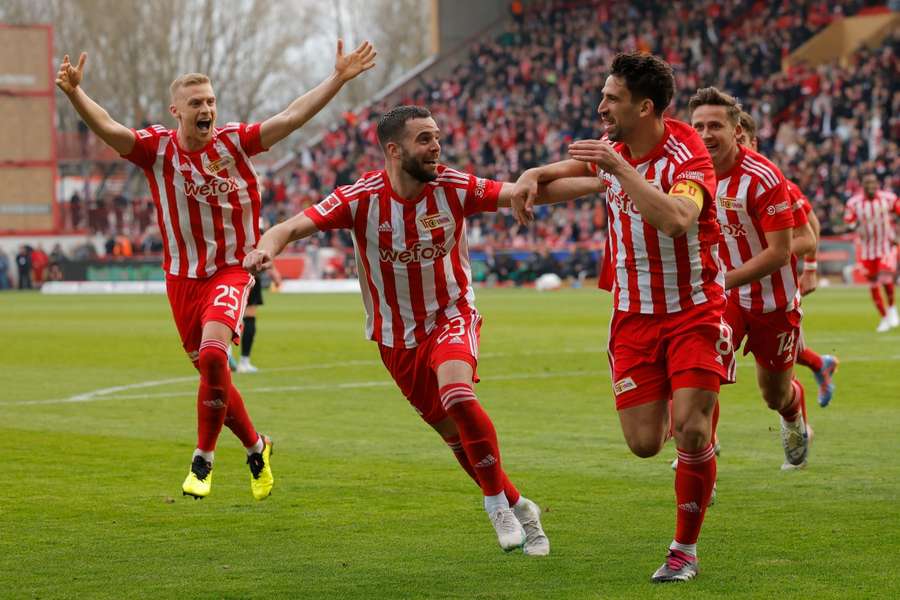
[378,313,481,425]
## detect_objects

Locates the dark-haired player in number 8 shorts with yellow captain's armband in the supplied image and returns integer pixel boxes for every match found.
[513,53,734,582]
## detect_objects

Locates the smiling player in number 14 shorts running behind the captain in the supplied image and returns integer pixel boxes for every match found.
[688,87,811,469]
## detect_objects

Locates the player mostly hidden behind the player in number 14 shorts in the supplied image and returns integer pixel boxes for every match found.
[736,111,840,408]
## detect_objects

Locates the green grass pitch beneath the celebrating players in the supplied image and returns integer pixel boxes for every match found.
[0,288,900,599]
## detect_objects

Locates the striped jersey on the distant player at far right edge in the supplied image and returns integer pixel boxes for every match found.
[844,190,900,260]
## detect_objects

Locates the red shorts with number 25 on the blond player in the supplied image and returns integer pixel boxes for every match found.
[166,266,255,361]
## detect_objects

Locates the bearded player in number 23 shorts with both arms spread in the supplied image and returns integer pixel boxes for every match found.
[244,106,600,555]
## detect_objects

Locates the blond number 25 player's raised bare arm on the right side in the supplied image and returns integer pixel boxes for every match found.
[259,40,377,148]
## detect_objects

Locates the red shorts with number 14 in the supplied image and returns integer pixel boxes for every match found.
[725,300,802,371]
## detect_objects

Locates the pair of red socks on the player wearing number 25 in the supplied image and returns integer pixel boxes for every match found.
[196,340,259,452]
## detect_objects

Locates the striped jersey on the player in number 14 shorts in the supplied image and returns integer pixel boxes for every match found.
[716,146,807,313]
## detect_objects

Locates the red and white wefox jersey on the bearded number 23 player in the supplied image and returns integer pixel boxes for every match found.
[305,166,502,348]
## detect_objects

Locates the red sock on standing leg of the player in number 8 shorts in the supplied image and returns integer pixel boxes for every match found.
[675,443,716,556]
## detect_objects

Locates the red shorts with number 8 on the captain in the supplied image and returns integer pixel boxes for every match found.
[608,300,735,410]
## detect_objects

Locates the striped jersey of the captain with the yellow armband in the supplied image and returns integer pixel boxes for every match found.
[590,119,725,314]
